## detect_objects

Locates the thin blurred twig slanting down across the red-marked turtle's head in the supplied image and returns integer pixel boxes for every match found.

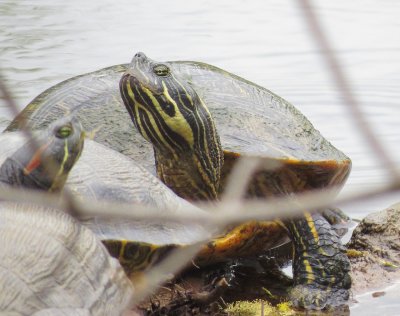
[0,74,81,216]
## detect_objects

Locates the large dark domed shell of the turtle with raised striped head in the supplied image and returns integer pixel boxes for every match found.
[7,61,351,191]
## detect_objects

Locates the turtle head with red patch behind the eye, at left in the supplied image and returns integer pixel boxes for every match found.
[0,116,84,192]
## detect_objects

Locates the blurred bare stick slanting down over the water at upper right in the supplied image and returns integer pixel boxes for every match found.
[298,0,400,180]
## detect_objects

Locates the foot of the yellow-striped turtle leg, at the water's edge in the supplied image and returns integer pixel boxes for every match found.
[289,285,350,310]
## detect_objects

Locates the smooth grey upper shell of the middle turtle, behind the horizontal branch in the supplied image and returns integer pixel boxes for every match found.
[66,140,211,246]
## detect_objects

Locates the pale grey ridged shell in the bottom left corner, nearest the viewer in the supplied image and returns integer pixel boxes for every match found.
[0,202,133,315]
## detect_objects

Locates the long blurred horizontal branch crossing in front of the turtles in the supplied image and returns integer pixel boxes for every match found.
[0,181,400,225]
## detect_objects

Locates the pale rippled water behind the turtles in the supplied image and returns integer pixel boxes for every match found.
[0,0,400,315]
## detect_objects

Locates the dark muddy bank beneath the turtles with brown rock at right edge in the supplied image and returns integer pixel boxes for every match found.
[135,203,400,315]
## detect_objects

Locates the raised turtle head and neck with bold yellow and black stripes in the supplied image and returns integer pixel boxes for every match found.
[120,53,223,200]
